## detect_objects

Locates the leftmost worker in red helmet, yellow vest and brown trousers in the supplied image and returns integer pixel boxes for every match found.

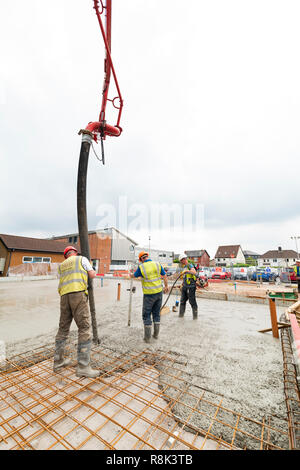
[53,246,100,377]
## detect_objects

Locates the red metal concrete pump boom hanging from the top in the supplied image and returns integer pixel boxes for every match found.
[86,0,123,142]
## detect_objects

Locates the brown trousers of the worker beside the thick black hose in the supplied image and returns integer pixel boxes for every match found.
[56,291,92,343]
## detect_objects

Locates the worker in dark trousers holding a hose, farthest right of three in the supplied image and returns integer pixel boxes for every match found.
[179,254,198,320]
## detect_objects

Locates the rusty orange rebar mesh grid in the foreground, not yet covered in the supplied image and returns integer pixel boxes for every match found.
[0,344,289,450]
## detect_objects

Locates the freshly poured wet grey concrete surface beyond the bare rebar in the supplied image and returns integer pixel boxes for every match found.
[0,279,286,445]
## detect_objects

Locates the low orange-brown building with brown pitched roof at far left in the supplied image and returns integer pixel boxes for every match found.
[0,234,72,277]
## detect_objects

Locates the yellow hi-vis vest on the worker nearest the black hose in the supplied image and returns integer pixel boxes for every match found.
[58,256,88,295]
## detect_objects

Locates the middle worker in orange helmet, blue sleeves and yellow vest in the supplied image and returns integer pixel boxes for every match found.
[131,251,169,343]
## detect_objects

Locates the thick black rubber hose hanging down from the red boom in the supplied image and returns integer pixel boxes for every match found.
[77,130,100,344]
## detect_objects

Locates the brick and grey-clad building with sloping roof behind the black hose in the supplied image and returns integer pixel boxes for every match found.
[52,227,137,274]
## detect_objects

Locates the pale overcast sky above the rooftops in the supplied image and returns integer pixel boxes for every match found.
[0,0,300,257]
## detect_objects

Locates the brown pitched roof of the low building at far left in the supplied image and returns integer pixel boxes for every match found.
[0,234,79,253]
